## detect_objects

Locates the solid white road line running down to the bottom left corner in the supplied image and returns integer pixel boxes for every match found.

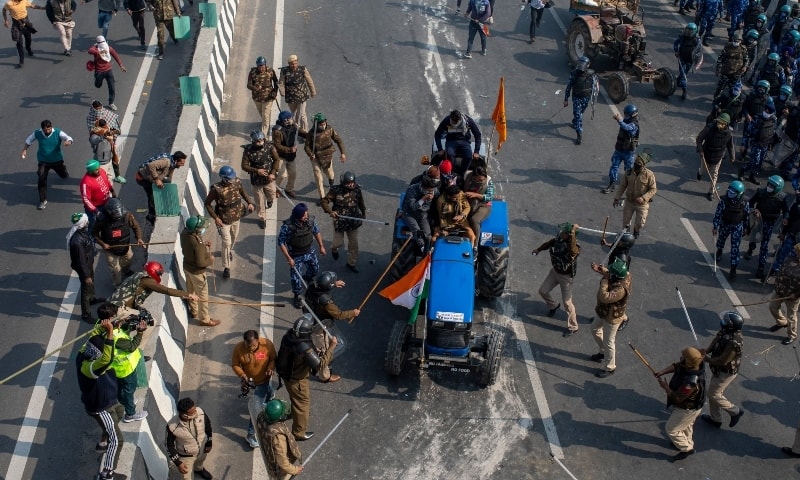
[5,271,80,480]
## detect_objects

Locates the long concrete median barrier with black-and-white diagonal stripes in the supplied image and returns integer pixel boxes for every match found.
[117,0,239,480]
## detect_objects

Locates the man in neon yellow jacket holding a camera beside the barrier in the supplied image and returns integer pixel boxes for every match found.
[97,302,147,423]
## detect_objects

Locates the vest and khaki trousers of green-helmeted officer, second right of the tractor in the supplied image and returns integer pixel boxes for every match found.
[591,273,631,371]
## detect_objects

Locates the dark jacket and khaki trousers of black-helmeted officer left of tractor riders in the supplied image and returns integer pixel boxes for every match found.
[320,184,367,269]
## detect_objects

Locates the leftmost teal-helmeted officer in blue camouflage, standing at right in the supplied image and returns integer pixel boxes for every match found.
[711,180,750,280]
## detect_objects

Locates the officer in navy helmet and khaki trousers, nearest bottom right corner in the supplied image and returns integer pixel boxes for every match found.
[700,311,744,428]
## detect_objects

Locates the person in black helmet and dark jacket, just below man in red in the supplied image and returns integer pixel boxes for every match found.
[92,197,144,288]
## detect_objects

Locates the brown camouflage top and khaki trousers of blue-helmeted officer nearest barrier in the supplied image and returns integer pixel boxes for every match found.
[205,178,253,268]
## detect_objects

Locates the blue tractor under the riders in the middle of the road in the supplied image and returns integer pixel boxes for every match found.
[384,191,509,387]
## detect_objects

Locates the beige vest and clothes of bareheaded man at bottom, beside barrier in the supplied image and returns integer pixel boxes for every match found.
[166,407,211,480]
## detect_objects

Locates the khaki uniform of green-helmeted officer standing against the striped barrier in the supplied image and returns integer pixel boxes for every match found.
[181,229,213,324]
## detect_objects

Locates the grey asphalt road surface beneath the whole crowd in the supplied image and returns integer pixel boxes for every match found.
[0,0,800,479]
